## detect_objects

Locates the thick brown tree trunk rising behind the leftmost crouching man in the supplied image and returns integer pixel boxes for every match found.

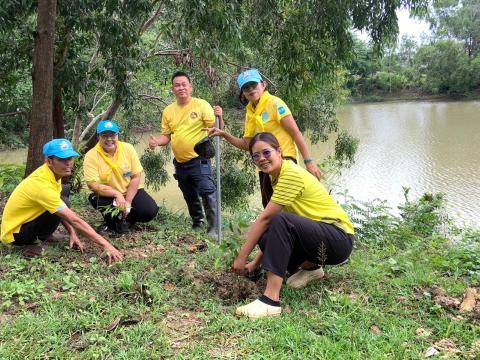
[25,0,57,176]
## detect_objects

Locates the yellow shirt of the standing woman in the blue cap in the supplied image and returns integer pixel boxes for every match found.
[243,93,298,159]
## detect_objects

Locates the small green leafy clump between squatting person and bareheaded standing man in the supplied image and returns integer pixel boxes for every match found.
[140,147,171,191]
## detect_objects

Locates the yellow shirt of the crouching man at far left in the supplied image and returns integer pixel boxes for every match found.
[0,164,67,244]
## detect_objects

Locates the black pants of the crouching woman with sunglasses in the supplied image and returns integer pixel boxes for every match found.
[258,212,354,277]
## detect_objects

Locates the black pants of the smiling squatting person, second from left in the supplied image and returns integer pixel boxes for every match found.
[88,189,158,229]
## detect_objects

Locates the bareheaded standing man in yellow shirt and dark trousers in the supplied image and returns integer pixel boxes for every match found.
[149,71,218,235]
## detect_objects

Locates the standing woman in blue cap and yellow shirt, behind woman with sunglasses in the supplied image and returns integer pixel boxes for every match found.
[204,69,322,207]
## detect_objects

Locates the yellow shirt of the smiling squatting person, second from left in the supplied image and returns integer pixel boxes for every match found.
[83,141,143,194]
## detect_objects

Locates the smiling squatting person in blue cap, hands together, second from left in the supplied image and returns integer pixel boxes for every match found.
[83,120,158,233]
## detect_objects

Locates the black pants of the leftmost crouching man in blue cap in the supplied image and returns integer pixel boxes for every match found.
[13,184,70,246]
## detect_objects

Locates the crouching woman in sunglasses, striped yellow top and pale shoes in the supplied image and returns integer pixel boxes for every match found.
[233,132,354,319]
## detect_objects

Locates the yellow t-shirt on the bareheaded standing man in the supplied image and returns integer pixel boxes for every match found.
[162,97,215,163]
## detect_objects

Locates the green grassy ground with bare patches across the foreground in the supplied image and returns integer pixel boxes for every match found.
[0,193,480,359]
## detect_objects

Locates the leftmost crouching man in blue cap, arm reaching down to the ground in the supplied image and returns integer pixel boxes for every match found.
[0,139,123,262]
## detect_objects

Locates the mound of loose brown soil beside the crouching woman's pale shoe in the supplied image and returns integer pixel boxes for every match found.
[195,271,266,305]
